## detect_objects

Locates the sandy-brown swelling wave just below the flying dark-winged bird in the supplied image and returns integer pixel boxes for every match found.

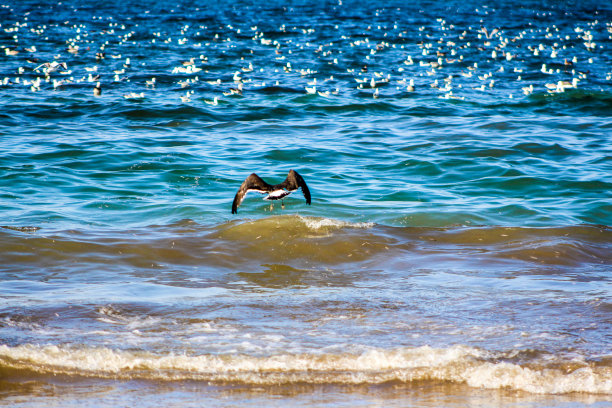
[0,215,612,269]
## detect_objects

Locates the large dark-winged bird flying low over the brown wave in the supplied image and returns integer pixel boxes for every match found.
[232,169,310,214]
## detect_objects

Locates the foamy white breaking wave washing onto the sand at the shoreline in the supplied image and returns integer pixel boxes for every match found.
[0,344,612,394]
